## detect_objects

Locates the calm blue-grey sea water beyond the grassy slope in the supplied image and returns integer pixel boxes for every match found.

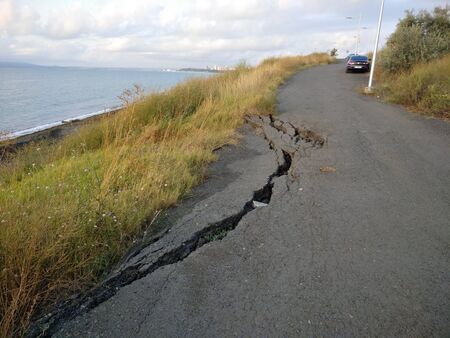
[0,65,207,133]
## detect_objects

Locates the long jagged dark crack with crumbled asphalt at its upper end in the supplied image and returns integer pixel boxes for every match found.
[27,116,325,337]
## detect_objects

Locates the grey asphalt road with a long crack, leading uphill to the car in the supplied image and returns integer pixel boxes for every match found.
[54,64,450,337]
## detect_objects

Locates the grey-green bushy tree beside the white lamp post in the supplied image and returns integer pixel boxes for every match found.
[381,6,450,73]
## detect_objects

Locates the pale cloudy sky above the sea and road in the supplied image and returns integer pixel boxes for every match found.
[0,0,449,68]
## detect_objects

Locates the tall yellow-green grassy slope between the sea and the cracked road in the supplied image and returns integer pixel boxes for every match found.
[0,54,330,336]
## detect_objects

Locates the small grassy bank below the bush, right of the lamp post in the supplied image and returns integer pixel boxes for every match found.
[378,55,450,119]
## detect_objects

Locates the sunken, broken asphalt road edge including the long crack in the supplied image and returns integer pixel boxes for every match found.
[34,116,325,336]
